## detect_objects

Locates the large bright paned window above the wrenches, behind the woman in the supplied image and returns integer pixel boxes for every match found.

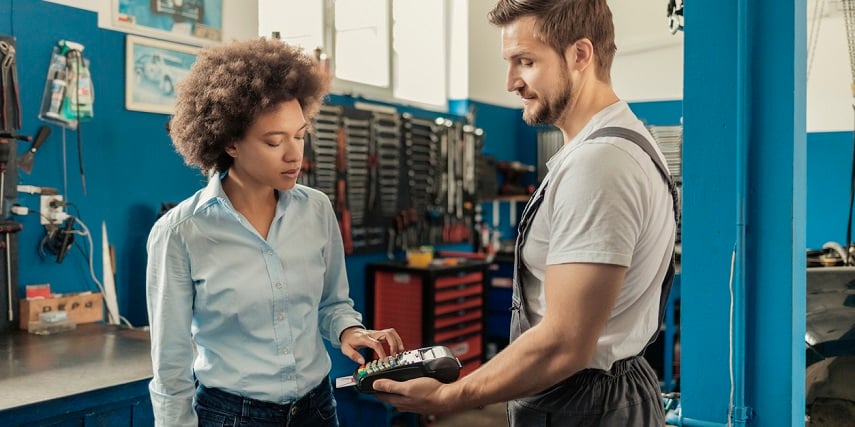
[258,0,449,110]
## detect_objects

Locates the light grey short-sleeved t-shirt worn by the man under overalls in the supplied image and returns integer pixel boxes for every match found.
[522,101,676,370]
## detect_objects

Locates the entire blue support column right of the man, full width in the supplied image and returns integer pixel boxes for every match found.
[681,0,804,426]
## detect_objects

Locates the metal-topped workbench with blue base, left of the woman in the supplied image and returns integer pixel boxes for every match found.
[0,324,154,426]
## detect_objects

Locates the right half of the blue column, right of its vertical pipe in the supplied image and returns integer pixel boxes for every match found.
[746,0,808,426]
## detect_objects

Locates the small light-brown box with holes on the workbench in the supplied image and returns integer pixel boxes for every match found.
[19,292,104,330]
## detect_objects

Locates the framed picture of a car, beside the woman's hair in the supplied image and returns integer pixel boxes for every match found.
[125,35,199,114]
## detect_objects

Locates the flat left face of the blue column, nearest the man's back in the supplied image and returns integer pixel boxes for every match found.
[680,1,737,423]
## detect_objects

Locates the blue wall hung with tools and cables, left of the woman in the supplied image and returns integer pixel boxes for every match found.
[0,0,204,325]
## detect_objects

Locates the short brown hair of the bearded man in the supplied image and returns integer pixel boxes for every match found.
[488,0,617,82]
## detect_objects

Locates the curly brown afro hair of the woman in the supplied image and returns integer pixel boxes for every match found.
[168,38,329,173]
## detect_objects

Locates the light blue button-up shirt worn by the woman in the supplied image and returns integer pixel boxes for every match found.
[146,178,362,426]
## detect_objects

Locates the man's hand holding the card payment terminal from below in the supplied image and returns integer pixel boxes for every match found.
[372,377,464,415]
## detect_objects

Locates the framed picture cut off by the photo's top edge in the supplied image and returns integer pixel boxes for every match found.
[111,0,223,46]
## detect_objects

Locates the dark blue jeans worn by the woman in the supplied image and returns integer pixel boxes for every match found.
[193,378,338,427]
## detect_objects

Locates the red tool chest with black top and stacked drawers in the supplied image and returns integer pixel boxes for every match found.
[365,260,489,377]
